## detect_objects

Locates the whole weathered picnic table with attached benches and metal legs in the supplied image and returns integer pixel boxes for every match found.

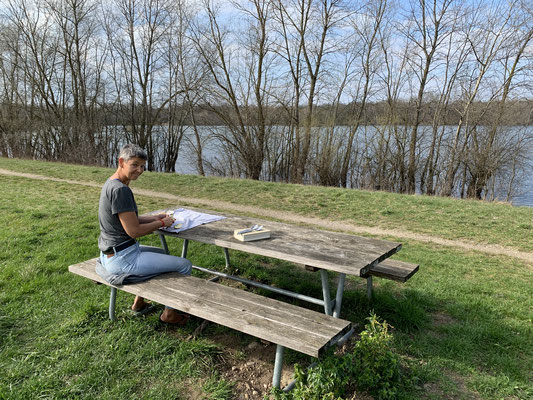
[69,209,418,390]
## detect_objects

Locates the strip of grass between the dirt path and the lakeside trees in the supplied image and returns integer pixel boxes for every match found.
[0,158,533,252]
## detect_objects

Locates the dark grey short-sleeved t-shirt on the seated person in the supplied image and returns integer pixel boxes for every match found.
[98,179,138,252]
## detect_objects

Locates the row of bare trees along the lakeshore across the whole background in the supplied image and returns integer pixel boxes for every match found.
[0,0,533,202]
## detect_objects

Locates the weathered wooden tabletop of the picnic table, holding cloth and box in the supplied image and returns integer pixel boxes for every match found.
[153,207,401,276]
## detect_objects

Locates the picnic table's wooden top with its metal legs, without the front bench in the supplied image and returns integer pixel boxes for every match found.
[152,209,404,317]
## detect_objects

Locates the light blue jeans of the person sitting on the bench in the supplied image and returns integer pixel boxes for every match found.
[100,243,192,275]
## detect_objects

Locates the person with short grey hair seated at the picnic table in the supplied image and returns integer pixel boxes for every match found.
[98,144,192,325]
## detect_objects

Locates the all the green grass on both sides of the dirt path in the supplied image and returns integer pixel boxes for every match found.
[0,159,533,399]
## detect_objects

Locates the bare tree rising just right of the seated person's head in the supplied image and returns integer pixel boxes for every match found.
[106,0,181,169]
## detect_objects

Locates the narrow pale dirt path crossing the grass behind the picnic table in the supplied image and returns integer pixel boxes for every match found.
[0,168,533,265]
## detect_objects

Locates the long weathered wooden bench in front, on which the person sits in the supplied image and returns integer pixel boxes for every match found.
[68,259,353,388]
